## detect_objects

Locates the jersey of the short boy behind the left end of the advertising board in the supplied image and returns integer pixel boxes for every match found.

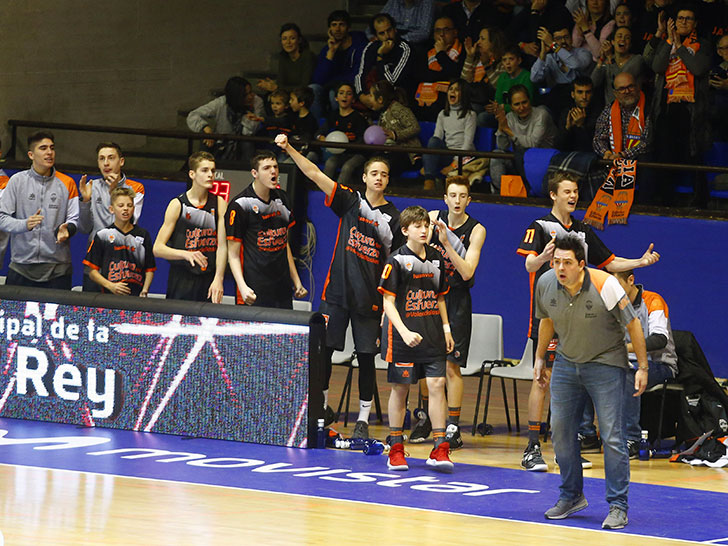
[83,224,157,296]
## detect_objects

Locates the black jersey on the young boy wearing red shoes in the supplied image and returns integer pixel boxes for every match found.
[379,245,449,363]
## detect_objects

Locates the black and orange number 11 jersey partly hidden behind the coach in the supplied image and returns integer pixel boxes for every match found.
[516,212,614,339]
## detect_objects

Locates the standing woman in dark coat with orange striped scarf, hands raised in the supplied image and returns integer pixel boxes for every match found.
[648,6,711,205]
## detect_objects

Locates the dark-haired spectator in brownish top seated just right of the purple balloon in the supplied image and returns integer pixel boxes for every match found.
[371,80,422,176]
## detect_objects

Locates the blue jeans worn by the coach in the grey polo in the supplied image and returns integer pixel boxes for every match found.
[551,353,629,510]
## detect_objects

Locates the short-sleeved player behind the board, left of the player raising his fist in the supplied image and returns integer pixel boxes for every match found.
[225,151,308,309]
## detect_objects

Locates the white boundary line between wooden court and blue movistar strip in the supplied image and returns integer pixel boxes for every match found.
[0,462,704,546]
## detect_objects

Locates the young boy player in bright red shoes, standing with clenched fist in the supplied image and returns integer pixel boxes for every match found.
[379,206,455,472]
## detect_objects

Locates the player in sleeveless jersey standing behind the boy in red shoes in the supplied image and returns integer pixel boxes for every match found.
[410,176,485,449]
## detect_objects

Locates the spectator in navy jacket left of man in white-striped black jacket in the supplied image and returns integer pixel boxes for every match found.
[310,10,368,119]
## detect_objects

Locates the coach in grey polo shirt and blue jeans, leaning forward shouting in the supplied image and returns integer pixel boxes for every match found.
[534,237,647,529]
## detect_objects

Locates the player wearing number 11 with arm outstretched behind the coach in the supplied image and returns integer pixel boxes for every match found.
[517,172,660,471]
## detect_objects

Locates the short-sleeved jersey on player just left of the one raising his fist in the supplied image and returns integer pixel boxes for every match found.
[225,184,295,299]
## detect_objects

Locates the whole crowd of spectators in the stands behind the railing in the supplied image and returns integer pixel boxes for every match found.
[188,0,728,204]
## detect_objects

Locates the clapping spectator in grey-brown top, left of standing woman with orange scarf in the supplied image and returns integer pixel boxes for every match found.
[592,27,649,104]
